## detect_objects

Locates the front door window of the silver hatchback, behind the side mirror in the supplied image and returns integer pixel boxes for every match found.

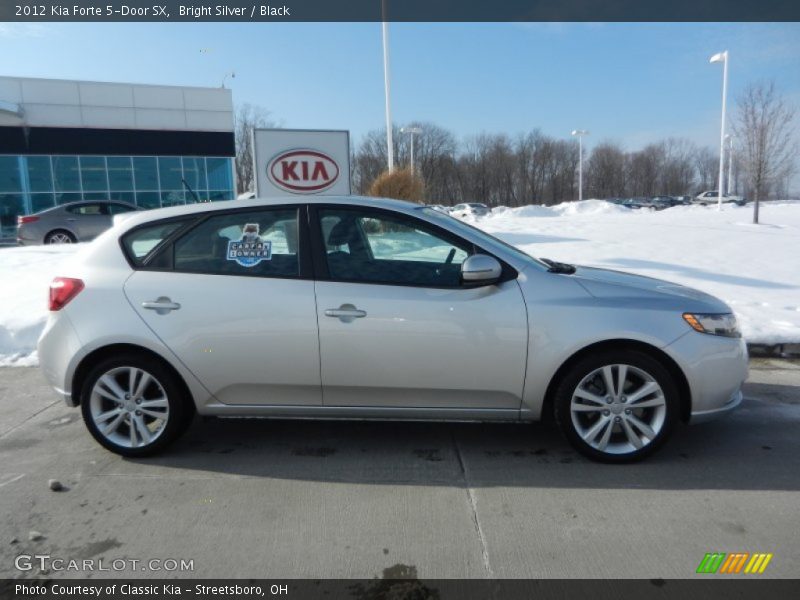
[319,209,473,287]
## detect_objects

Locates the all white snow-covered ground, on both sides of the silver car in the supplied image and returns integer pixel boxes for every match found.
[0,200,800,366]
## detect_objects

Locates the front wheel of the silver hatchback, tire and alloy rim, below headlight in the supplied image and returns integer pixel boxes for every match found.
[555,350,679,463]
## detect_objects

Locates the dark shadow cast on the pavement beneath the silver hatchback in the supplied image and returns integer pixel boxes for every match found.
[129,390,800,491]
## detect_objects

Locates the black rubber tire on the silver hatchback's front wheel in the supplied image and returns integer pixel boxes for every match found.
[554,350,680,463]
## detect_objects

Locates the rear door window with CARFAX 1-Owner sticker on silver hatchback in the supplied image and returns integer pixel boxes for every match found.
[173,208,300,277]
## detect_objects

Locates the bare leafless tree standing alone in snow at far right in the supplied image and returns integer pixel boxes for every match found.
[733,82,798,223]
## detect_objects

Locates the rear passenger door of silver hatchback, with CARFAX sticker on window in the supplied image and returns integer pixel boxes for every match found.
[124,205,322,405]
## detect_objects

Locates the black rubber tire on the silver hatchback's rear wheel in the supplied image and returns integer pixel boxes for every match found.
[81,353,195,458]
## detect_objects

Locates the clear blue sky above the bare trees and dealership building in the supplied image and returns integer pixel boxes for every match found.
[0,23,800,150]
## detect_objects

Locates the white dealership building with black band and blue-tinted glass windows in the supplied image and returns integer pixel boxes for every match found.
[0,77,235,237]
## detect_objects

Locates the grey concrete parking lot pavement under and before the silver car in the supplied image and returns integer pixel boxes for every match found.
[0,360,800,578]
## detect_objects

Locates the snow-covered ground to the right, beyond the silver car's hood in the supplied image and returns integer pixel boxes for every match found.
[475,200,800,344]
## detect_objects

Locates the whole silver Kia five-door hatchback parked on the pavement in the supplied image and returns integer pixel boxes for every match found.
[39,197,747,462]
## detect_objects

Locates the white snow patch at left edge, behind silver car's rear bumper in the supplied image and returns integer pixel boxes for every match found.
[0,244,83,367]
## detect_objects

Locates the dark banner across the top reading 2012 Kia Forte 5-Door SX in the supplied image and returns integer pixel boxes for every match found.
[0,0,800,22]
